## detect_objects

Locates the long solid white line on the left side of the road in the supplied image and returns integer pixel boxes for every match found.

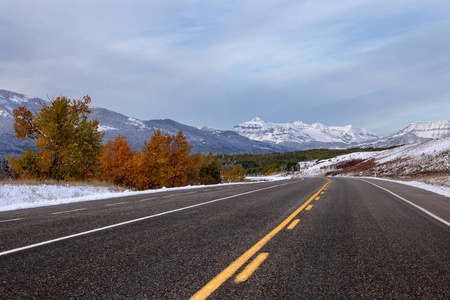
[0,181,296,256]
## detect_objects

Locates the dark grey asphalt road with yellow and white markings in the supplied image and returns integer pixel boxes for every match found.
[0,178,450,299]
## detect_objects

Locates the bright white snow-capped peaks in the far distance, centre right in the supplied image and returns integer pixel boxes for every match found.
[232,118,379,150]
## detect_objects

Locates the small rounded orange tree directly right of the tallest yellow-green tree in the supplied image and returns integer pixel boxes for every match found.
[99,135,134,186]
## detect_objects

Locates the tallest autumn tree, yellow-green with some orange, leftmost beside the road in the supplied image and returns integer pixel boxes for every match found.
[10,96,104,180]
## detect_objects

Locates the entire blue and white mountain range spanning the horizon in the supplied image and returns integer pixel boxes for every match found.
[0,90,450,155]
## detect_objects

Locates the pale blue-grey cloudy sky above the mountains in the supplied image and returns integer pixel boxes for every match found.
[0,0,450,135]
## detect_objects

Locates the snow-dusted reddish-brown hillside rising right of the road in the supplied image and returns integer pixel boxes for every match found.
[301,137,450,186]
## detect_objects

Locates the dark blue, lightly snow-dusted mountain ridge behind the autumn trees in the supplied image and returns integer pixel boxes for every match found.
[0,90,284,155]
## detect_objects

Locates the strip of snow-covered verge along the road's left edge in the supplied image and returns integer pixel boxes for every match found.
[0,175,291,212]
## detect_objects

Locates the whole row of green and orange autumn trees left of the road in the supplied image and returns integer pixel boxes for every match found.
[8,96,225,190]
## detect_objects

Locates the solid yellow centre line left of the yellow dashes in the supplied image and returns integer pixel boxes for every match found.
[190,179,331,300]
